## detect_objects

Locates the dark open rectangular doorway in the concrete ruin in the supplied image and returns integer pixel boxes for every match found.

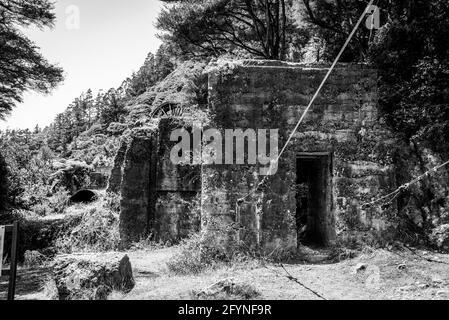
[296,153,334,247]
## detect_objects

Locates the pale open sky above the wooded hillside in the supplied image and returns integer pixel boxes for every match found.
[0,0,162,129]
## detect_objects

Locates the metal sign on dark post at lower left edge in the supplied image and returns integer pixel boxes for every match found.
[0,222,19,300]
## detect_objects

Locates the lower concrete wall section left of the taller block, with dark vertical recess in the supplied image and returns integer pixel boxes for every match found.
[112,119,201,246]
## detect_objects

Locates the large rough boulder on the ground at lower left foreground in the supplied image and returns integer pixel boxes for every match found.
[52,255,135,300]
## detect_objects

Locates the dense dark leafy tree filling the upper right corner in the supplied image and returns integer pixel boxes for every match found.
[371,0,449,154]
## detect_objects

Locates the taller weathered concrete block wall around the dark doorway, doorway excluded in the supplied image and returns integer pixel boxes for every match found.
[202,62,395,250]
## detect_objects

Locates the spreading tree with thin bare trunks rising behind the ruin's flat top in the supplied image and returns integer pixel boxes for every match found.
[157,0,305,60]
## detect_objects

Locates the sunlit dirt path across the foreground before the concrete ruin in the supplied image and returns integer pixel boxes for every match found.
[0,248,449,300]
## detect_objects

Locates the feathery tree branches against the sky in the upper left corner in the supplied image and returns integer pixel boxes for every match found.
[0,0,63,119]
